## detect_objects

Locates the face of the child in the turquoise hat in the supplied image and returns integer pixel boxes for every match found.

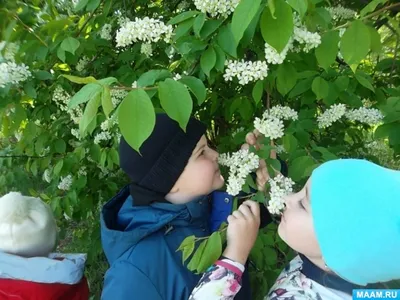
[278,179,322,259]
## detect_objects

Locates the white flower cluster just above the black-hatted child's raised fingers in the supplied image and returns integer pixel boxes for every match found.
[254,105,298,140]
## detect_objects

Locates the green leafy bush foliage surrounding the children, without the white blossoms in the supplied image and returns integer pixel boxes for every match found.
[0,0,400,299]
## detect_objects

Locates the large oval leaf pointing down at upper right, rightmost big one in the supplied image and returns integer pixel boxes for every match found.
[340,20,371,72]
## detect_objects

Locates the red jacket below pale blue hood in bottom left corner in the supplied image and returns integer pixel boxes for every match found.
[0,278,89,300]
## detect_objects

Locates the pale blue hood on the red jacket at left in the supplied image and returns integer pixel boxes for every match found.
[0,252,86,285]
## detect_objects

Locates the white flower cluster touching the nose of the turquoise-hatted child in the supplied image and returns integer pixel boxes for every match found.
[267,174,294,215]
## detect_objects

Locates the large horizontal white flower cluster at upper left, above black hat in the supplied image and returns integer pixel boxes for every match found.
[115,17,173,47]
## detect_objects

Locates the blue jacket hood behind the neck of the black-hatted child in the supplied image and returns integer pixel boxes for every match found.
[101,186,209,264]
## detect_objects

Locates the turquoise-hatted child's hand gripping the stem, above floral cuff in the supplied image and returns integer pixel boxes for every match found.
[223,200,260,265]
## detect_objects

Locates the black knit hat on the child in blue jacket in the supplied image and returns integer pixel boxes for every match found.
[119,113,206,205]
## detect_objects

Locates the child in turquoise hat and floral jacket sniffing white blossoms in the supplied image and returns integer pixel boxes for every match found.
[190,159,400,300]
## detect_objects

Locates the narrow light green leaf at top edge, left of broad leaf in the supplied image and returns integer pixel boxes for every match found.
[231,0,261,44]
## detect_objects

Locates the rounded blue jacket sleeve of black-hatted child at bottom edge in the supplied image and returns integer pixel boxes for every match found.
[101,261,163,300]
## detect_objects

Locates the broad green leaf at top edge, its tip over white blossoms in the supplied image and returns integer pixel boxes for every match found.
[260,0,294,53]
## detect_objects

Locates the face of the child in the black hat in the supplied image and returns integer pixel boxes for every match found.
[166,135,224,204]
